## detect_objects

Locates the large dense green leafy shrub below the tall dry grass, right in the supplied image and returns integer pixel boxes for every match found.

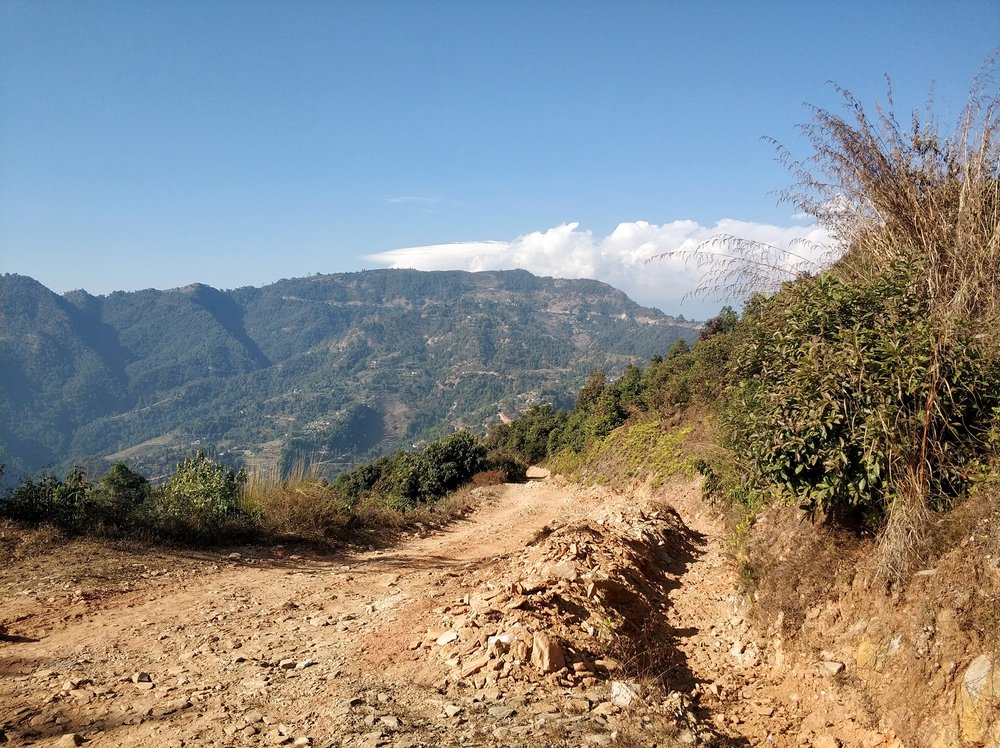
[723,264,1000,523]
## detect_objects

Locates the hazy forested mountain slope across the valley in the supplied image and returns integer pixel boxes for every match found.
[0,270,698,476]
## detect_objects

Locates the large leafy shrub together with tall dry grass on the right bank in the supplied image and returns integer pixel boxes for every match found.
[722,74,1000,578]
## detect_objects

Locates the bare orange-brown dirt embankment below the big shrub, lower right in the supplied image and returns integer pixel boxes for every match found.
[748,494,1000,748]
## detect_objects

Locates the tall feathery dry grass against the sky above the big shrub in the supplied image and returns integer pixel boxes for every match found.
[785,71,1000,320]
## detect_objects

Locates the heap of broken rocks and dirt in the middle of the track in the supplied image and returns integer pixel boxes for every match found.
[410,507,713,743]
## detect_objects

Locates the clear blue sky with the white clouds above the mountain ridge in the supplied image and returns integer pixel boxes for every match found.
[0,0,1000,317]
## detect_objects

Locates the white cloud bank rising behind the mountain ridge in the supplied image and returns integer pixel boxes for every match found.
[364,218,834,317]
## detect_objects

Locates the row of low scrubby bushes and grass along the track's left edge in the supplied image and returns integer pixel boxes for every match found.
[0,432,504,544]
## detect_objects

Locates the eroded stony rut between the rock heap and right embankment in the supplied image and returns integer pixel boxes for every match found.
[667,486,901,748]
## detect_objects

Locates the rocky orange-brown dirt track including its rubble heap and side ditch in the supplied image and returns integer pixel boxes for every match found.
[0,477,894,748]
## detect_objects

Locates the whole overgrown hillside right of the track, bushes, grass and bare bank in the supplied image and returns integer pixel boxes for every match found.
[480,71,1000,748]
